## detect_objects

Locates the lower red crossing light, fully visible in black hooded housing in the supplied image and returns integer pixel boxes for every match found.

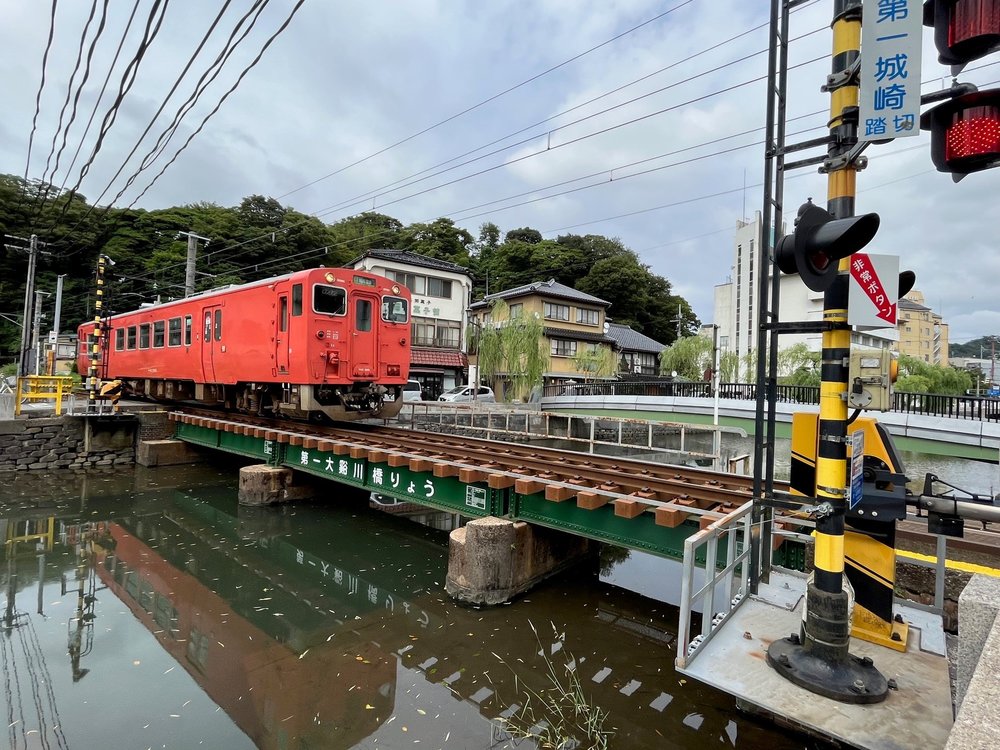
[920,89,1000,181]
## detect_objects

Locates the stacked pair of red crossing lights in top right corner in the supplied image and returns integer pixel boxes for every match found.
[920,0,1000,182]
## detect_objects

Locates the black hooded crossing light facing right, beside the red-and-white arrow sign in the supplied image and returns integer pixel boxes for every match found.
[774,200,879,292]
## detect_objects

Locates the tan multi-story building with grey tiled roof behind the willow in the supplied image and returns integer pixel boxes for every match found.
[469,279,613,390]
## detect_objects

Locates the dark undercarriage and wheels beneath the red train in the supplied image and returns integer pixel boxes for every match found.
[121,378,403,422]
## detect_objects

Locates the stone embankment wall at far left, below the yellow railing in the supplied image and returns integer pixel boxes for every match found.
[0,412,173,472]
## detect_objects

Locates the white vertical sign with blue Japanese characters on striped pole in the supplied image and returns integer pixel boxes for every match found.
[858,0,923,141]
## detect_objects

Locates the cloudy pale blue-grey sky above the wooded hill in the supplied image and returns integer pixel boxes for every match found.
[0,0,1000,341]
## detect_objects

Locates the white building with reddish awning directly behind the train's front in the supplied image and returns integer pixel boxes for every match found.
[348,250,472,400]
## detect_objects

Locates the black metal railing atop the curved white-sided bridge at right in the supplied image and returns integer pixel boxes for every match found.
[543,380,1000,421]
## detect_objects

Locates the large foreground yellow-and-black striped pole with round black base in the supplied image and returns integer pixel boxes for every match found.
[768,0,888,703]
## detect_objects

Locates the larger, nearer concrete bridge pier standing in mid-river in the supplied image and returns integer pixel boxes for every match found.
[445,516,597,604]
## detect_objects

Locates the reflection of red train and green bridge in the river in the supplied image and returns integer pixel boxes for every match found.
[101,493,804,748]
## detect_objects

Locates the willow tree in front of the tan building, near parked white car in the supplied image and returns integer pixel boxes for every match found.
[470,299,549,400]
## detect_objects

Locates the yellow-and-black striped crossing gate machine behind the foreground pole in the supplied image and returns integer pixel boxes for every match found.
[789,412,908,651]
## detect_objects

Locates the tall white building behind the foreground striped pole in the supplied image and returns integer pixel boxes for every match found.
[714,211,899,380]
